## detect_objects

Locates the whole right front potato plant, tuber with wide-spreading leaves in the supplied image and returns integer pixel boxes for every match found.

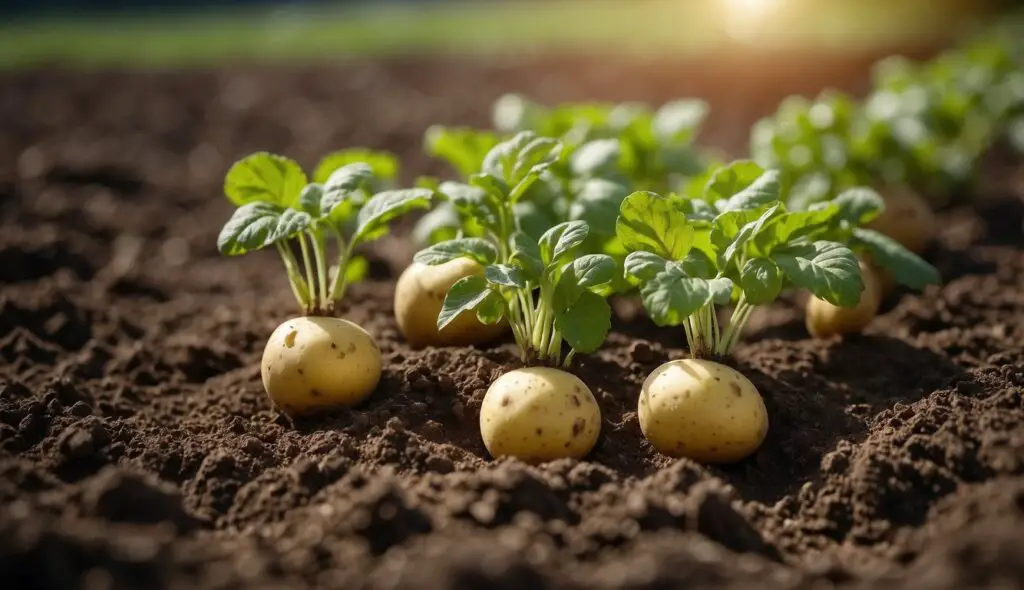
[617,161,937,462]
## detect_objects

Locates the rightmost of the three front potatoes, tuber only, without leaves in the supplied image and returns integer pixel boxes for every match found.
[637,359,768,463]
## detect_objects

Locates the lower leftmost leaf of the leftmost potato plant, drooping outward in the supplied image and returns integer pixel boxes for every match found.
[217,202,310,256]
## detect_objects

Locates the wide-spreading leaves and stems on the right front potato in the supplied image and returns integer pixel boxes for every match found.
[616,161,938,356]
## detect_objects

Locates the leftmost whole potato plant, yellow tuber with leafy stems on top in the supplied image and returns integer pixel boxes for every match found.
[217,151,432,414]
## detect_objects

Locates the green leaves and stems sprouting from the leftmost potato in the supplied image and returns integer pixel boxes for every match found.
[217,149,433,313]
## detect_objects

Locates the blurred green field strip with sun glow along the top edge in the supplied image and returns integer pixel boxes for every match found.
[0,0,1024,66]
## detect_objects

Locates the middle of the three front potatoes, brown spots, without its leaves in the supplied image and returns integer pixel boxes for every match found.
[480,367,601,463]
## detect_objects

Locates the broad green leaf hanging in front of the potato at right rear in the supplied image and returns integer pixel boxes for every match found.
[775,241,864,307]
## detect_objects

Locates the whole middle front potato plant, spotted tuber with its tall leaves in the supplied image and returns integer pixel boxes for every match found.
[415,132,617,462]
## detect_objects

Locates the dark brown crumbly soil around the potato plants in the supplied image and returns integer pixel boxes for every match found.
[0,49,1024,590]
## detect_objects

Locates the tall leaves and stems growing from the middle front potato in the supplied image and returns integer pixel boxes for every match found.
[415,131,618,365]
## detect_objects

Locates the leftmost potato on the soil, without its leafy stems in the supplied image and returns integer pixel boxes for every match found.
[261,317,381,414]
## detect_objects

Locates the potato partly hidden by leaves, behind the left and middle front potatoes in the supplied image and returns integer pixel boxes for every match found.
[394,258,508,348]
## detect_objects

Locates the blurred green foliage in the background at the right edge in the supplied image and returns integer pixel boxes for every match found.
[751,34,1024,209]
